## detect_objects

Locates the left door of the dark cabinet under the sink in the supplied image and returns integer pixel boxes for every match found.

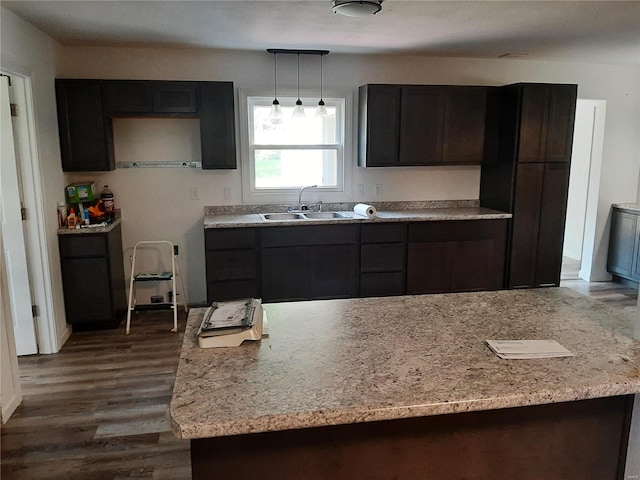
[262,247,311,302]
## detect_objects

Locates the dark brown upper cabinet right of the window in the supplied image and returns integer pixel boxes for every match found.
[358,85,495,167]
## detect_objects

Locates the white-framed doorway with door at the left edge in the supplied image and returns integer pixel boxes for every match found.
[0,66,59,355]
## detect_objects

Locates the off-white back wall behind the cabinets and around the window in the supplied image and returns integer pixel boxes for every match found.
[57,47,640,302]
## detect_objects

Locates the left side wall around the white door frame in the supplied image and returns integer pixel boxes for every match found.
[0,8,70,349]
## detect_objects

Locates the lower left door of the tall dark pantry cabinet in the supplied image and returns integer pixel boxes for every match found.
[509,163,544,288]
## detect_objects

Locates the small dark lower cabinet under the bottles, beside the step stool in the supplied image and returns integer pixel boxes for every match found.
[58,225,127,330]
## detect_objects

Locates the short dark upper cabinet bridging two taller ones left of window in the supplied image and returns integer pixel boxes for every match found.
[105,80,198,116]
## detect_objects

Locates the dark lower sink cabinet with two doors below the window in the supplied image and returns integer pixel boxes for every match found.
[262,225,359,302]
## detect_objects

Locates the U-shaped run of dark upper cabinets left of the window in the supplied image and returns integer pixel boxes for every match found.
[56,79,237,172]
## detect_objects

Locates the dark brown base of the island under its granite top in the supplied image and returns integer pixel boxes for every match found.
[191,395,633,480]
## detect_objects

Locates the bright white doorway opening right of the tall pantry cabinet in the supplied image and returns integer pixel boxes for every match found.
[561,99,607,281]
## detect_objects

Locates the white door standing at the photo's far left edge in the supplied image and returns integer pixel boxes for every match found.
[0,77,38,355]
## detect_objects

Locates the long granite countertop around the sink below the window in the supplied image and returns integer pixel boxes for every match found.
[204,204,512,228]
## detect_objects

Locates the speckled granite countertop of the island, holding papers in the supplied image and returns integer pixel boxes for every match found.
[170,288,640,439]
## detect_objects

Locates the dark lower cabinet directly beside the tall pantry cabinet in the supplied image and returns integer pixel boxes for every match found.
[407,219,507,294]
